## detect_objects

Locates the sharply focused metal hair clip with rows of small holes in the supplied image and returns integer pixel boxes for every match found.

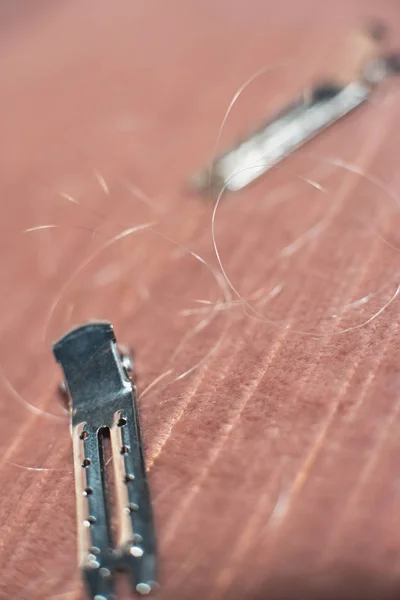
[53,322,157,600]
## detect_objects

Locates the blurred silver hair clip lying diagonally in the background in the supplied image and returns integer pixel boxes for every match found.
[190,25,400,197]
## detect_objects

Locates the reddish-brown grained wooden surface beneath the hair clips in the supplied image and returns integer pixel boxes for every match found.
[0,0,400,600]
